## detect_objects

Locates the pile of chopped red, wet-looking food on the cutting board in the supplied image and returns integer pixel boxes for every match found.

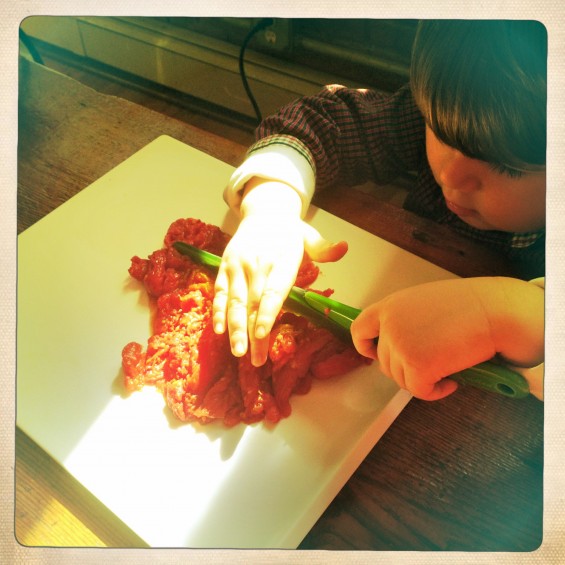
[122,218,365,427]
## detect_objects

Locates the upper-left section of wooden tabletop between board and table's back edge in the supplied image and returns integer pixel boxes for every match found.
[18,59,246,232]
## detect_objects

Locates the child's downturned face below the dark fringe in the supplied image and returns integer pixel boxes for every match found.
[426,128,545,232]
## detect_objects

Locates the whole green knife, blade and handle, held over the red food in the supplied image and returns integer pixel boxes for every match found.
[173,241,530,398]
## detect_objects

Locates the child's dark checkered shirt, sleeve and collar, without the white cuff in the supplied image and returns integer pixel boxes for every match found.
[249,85,545,278]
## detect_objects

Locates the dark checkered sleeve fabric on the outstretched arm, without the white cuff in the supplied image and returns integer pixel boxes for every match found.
[257,85,425,189]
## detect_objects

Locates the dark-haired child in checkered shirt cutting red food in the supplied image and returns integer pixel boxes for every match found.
[209,20,547,400]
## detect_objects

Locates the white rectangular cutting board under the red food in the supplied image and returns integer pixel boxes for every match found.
[17,136,454,548]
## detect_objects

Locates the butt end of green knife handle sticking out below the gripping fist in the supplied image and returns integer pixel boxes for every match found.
[450,361,530,398]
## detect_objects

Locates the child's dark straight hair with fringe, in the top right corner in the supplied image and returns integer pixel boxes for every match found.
[410,20,547,170]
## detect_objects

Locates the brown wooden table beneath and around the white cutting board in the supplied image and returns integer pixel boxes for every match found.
[15,56,543,551]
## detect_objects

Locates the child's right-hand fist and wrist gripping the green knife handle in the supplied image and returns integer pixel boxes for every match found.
[351,277,544,400]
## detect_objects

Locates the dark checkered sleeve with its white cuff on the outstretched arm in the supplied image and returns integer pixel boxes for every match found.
[224,85,425,216]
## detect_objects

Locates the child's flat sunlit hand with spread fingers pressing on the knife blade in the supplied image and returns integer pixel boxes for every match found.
[213,181,347,366]
